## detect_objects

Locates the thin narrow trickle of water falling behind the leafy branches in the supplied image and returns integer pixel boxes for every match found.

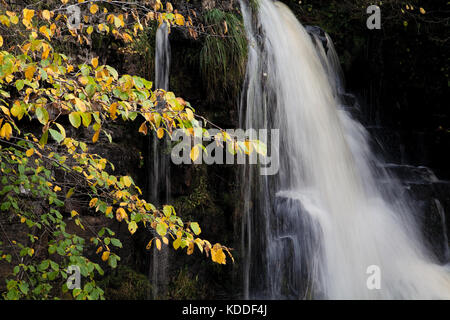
[148,22,170,299]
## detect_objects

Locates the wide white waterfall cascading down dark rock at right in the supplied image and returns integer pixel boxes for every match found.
[241,0,450,299]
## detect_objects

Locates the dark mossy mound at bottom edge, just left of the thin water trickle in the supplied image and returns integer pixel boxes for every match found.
[99,266,151,300]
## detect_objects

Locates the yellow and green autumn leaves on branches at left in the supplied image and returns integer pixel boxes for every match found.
[0,0,243,299]
